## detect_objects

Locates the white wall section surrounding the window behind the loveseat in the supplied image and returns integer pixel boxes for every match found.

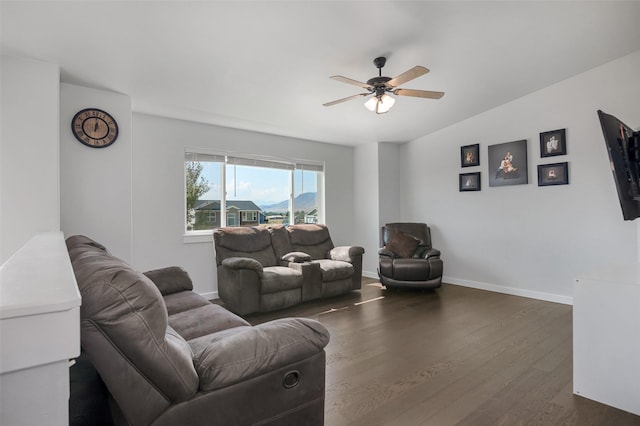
[133,114,358,297]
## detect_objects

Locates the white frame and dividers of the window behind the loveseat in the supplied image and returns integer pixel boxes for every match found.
[183,147,325,243]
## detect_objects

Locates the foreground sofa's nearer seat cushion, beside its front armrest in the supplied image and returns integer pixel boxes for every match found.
[169,302,249,340]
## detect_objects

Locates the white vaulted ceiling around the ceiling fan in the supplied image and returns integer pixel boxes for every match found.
[0,0,640,145]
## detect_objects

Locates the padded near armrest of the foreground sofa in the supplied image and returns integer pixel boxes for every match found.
[189,318,329,391]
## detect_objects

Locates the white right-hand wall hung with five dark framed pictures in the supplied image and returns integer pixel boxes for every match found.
[401,51,640,303]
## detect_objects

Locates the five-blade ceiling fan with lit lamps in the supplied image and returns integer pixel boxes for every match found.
[322,56,444,114]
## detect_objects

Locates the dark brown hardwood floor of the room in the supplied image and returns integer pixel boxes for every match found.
[246,278,640,426]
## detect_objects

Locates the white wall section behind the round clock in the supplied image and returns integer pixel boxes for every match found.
[60,84,133,263]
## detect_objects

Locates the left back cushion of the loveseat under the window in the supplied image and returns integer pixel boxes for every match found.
[213,226,277,267]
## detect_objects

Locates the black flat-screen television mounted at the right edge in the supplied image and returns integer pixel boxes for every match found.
[598,110,640,220]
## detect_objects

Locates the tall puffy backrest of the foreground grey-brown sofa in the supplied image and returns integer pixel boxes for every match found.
[67,235,198,404]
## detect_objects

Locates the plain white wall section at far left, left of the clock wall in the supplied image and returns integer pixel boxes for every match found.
[0,55,60,263]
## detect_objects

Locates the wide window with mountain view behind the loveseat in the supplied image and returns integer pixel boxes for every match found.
[185,150,324,234]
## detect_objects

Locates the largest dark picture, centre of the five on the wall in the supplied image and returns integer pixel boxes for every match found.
[489,139,529,186]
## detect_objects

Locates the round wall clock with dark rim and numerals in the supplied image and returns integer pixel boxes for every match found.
[71,108,118,148]
